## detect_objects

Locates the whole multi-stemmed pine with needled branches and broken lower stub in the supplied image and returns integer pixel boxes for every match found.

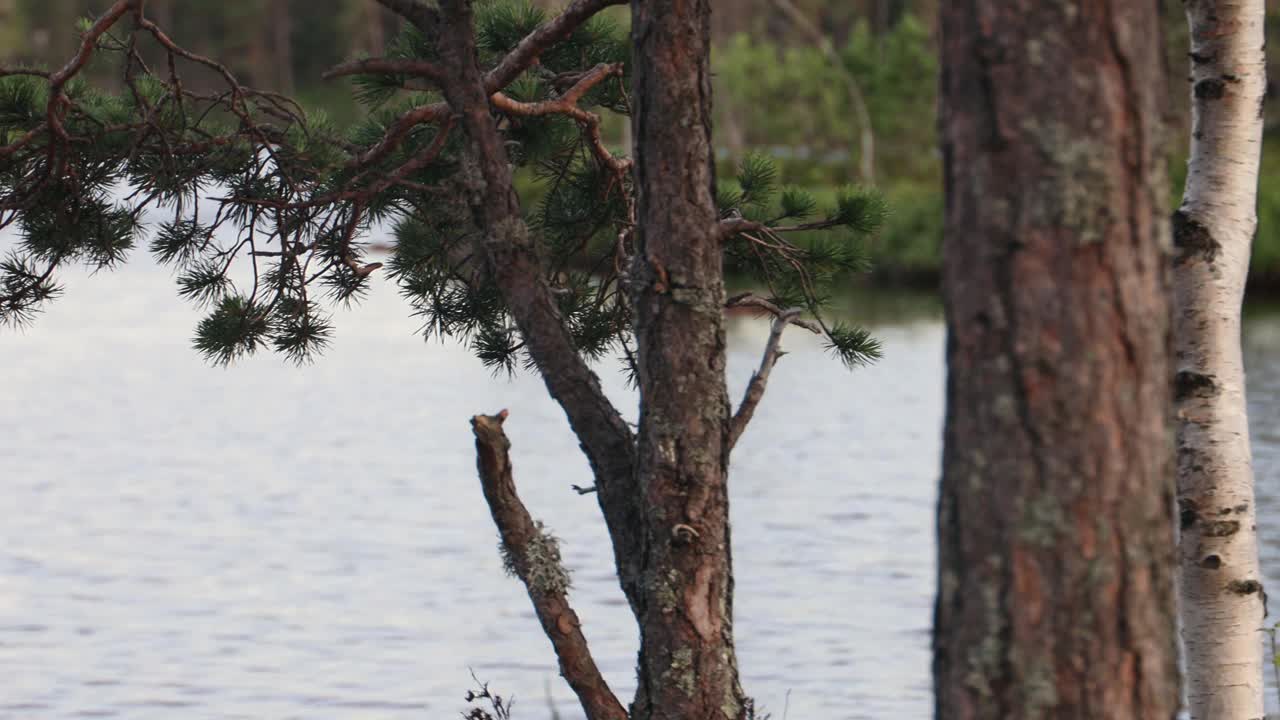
[0,0,886,719]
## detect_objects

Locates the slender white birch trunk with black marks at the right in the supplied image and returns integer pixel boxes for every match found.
[1174,0,1266,720]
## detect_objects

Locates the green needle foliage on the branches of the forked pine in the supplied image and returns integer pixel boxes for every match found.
[0,0,887,373]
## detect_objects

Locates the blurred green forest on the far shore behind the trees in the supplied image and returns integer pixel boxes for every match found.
[0,0,1280,290]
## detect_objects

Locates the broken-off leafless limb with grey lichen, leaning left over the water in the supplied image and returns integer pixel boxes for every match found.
[471,410,627,720]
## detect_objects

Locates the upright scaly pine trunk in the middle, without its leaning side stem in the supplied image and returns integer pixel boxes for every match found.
[631,0,745,720]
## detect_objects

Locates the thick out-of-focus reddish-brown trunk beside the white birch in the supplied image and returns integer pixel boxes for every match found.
[934,0,1179,720]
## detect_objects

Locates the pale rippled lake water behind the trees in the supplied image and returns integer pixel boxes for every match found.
[0,254,1280,720]
